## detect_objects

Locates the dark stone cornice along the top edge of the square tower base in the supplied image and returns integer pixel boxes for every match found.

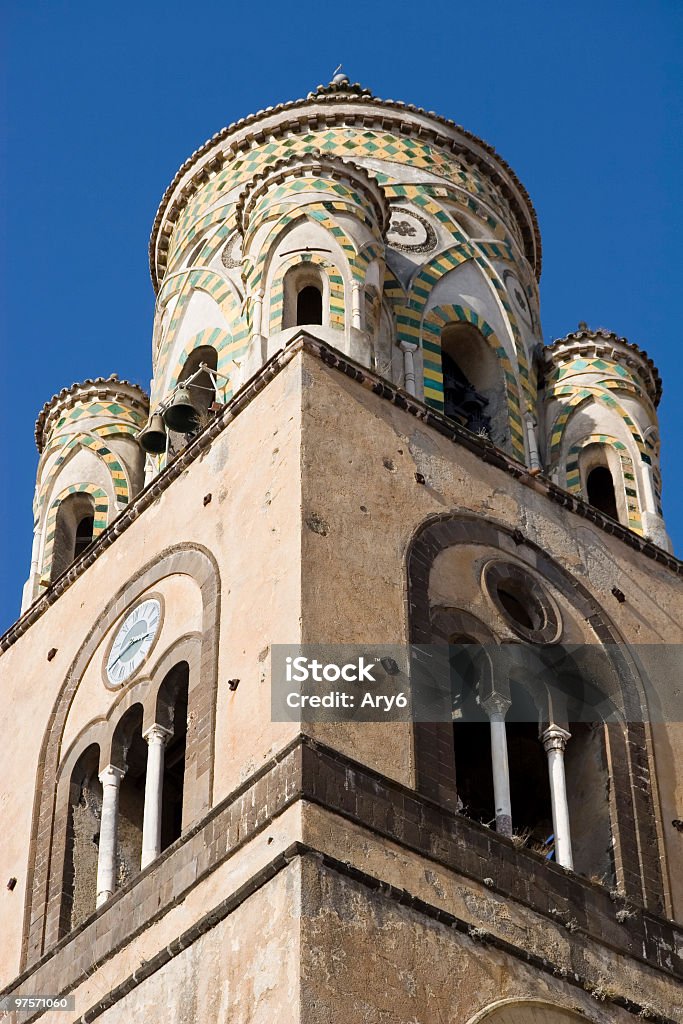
[0,331,683,651]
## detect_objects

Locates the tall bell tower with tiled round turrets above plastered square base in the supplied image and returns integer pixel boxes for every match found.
[0,74,683,1024]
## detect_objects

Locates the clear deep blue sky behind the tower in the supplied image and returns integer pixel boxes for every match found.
[0,0,683,630]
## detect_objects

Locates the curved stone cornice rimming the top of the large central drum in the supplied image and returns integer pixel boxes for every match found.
[150,86,542,291]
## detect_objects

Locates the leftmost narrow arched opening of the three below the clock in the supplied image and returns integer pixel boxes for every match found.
[59,743,102,935]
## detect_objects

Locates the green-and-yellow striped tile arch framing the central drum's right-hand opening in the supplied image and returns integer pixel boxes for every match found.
[422,305,525,462]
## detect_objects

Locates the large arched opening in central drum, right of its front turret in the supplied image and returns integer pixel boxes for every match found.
[441,323,507,437]
